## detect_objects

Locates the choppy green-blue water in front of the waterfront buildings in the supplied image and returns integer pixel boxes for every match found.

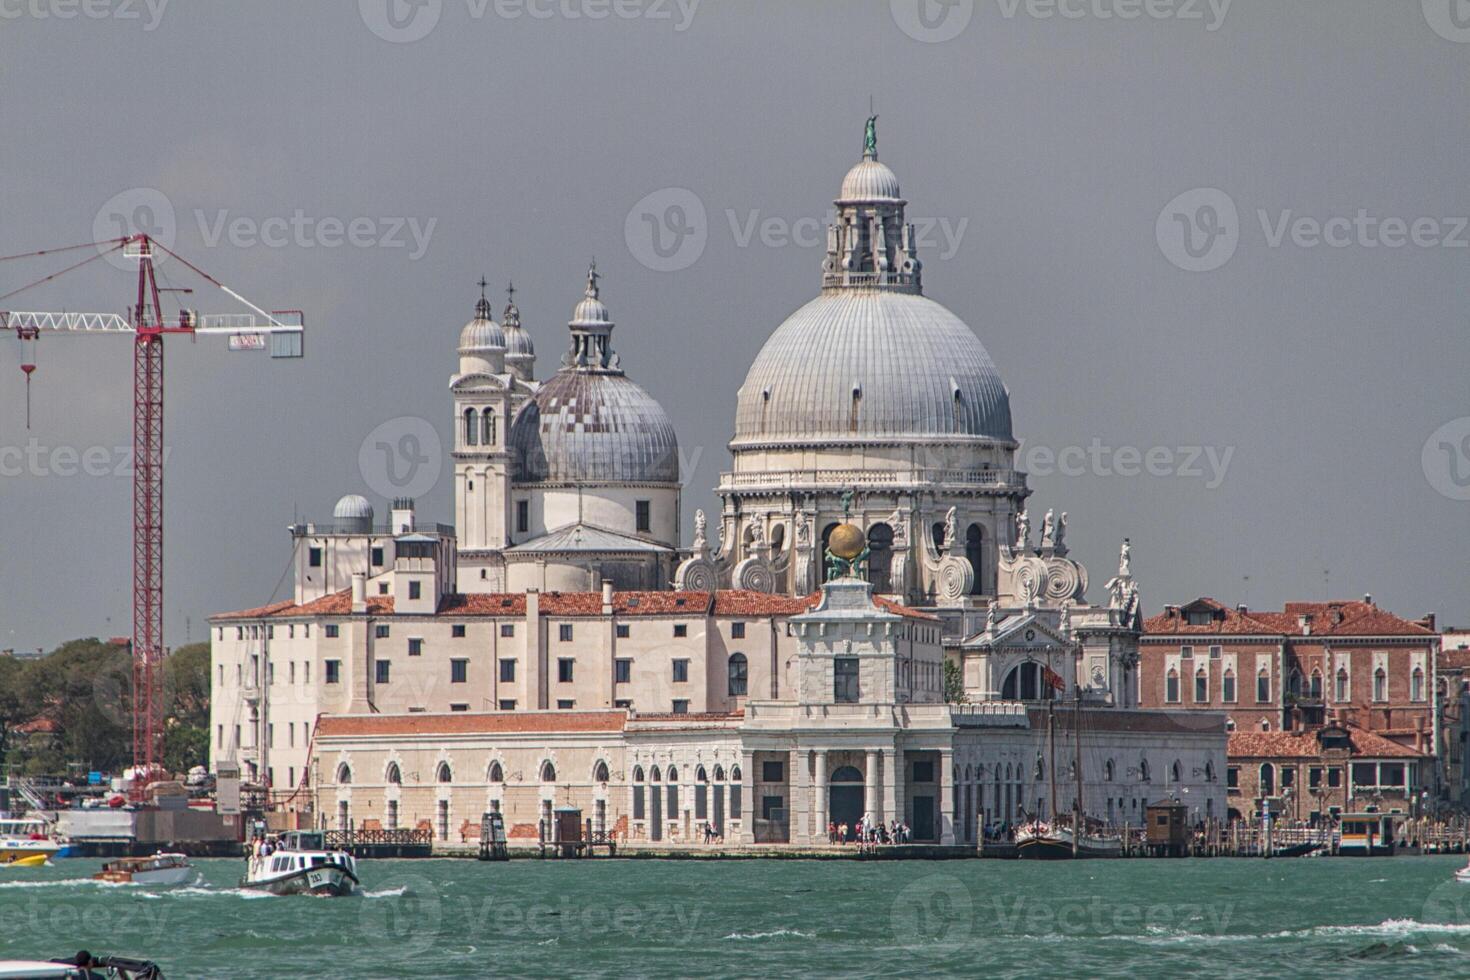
[0,857,1470,980]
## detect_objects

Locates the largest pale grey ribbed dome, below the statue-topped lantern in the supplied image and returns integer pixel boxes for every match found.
[734,288,1011,447]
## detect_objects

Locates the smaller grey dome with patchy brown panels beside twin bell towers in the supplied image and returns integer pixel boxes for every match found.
[510,369,679,483]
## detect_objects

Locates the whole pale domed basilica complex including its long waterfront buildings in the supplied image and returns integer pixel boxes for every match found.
[210,119,1226,846]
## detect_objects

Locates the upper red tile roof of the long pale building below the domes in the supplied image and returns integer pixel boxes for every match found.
[210,589,938,621]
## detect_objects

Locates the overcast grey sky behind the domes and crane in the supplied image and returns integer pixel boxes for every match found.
[0,0,1470,648]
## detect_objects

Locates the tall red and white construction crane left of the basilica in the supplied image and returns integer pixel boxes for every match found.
[0,234,306,799]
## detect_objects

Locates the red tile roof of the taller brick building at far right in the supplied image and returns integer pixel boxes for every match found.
[1144,597,1435,636]
